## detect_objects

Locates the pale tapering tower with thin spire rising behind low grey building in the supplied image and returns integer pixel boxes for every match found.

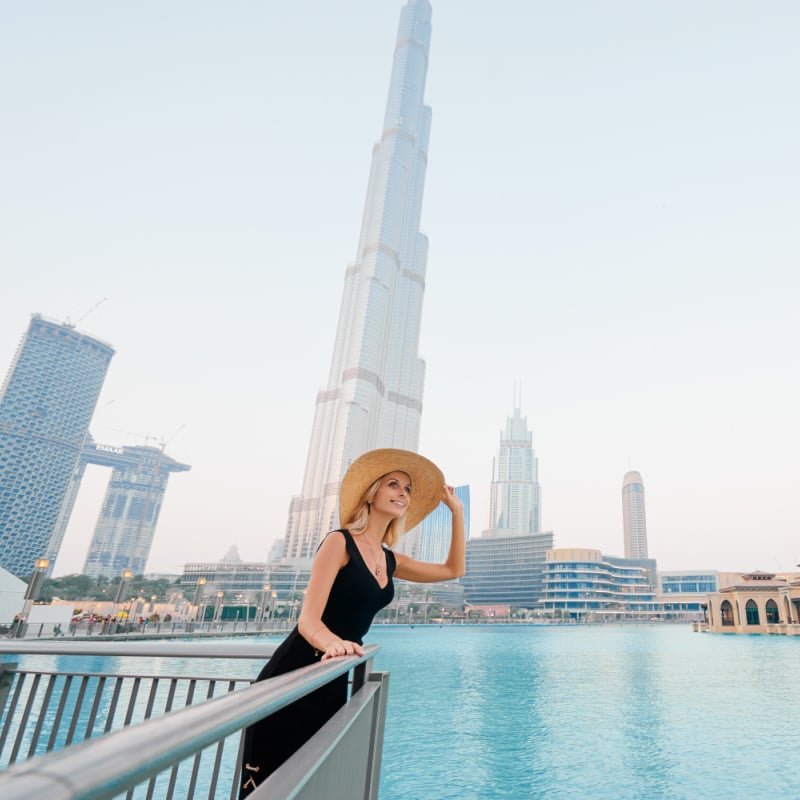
[489,408,541,533]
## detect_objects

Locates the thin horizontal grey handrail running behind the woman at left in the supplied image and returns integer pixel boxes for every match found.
[0,639,278,658]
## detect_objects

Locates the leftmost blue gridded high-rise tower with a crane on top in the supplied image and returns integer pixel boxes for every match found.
[0,314,114,576]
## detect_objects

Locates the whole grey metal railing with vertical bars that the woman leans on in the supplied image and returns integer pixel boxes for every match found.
[0,641,388,800]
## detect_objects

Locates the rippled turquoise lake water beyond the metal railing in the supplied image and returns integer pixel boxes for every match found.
[6,625,800,800]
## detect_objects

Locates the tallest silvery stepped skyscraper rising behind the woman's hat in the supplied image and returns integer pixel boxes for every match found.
[284,0,431,559]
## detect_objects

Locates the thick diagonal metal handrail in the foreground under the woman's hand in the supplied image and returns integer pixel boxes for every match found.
[0,645,379,800]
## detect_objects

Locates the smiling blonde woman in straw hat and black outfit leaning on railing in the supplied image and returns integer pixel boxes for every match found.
[240,449,465,798]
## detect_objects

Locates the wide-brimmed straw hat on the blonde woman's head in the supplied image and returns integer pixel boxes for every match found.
[339,448,444,531]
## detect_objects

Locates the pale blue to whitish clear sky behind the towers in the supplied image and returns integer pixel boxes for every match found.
[0,0,800,575]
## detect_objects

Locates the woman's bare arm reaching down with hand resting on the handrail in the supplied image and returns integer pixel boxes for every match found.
[297,531,364,661]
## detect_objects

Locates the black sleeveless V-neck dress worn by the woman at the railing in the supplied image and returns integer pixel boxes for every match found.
[239,530,396,798]
